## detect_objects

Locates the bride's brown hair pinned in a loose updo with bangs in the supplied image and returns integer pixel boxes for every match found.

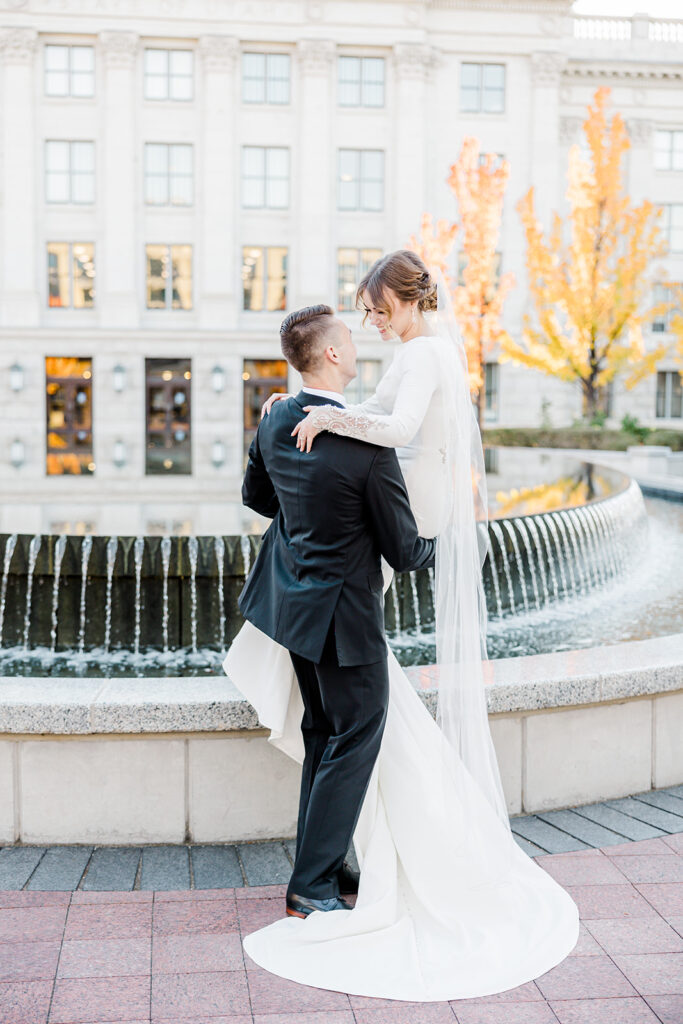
[355,249,436,327]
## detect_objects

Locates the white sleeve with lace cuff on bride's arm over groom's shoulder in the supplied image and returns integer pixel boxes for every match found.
[309,342,438,447]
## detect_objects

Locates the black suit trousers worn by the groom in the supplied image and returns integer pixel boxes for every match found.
[288,625,389,899]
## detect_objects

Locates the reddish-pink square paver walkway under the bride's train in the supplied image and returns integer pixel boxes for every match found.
[0,833,683,1024]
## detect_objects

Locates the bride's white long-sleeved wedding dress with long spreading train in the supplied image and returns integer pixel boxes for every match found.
[223,337,579,1001]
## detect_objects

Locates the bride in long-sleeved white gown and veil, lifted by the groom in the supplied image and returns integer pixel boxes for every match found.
[223,250,579,1001]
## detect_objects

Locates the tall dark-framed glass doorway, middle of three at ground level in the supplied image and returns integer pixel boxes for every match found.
[144,359,193,476]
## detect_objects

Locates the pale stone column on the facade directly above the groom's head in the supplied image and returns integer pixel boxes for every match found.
[288,39,337,308]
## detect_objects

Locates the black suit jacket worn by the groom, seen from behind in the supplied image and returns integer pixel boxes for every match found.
[240,391,436,666]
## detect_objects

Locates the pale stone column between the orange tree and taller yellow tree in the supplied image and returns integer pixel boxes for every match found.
[530,50,566,230]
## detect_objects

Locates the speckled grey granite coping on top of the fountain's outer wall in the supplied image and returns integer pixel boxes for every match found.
[0,633,683,735]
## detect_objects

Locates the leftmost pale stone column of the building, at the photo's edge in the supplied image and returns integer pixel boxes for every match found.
[0,29,39,327]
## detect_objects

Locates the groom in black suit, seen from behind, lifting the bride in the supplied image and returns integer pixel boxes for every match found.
[240,305,435,918]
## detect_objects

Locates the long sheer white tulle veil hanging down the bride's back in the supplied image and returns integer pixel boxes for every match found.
[427,269,510,828]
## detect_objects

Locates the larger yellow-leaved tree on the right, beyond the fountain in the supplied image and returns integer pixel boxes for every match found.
[501,88,668,418]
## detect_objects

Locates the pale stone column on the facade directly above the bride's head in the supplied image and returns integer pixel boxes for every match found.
[393,43,436,248]
